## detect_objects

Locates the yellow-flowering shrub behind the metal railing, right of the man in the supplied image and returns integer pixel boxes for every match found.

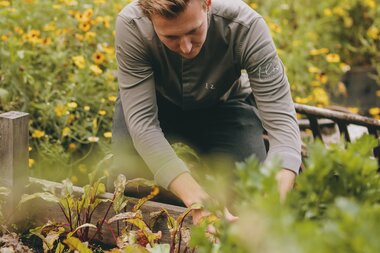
[247,0,380,110]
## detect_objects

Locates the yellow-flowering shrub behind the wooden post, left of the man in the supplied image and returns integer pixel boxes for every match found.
[0,0,131,181]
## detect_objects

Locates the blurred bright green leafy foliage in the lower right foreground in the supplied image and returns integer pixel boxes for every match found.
[191,136,380,253]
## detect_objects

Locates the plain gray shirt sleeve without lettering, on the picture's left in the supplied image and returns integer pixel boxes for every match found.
[115,15,188,189]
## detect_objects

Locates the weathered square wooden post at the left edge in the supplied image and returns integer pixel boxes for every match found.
[0,112,29,217]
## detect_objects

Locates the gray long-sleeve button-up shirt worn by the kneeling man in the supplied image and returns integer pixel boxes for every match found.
[116,0,301,188]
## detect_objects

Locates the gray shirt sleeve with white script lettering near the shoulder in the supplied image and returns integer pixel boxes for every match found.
[240,17,301,173]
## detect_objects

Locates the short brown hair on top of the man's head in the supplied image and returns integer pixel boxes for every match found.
[138,0,207,18]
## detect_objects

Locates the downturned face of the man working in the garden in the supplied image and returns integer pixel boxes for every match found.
[151,0,211,59]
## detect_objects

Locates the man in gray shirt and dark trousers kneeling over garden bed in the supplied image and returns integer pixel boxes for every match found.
[113,0,301,222]
